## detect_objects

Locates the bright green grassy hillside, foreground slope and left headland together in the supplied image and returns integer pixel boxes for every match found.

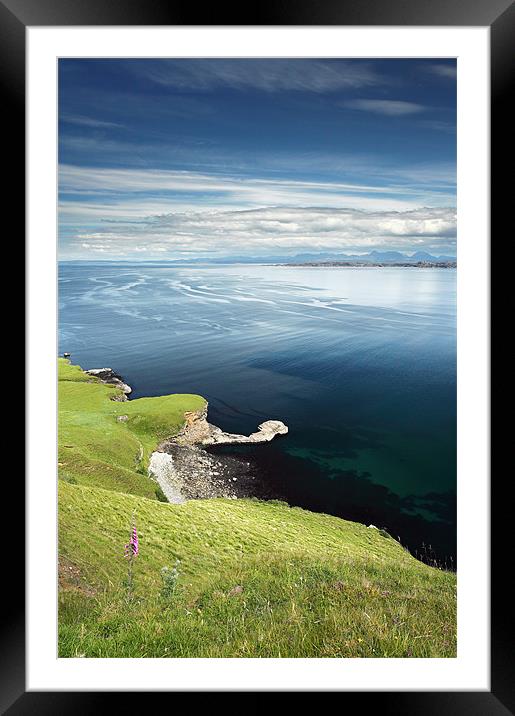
[59,363,456,657]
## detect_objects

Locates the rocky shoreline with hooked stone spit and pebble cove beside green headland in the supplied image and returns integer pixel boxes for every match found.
[85,368,288,504]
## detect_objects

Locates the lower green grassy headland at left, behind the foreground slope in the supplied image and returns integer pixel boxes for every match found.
[58,358,205,497]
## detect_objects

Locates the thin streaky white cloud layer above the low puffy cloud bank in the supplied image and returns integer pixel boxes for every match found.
[59,165,454,234]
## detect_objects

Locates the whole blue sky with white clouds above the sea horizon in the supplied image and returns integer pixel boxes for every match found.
[59,59,456,260]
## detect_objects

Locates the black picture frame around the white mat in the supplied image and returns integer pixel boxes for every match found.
[0,0,504,716]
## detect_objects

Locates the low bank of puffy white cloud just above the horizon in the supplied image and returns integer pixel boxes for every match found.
[67,207,456,256]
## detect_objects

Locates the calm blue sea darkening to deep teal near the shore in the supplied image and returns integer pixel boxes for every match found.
[59,263,456,560]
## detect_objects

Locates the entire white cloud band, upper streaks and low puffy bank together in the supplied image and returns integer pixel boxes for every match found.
[59,165,456,256]
